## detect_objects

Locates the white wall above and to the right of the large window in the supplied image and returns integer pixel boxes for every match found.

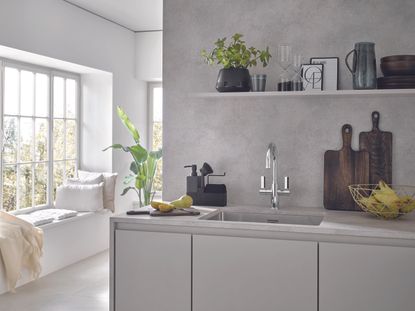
[0,0,147,209]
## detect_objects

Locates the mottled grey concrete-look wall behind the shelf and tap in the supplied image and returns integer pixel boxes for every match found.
[163,0,415,208]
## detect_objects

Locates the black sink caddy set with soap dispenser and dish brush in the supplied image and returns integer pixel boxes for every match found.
[185,162,227,206]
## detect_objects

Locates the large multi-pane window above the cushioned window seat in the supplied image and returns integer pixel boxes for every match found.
[0,62,79,211]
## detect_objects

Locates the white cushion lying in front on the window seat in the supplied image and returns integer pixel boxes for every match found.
[55,183,104,212]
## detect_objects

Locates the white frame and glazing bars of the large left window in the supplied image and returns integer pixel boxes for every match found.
[0,57,82,214]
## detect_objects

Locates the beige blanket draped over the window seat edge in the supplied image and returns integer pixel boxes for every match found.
[0,211,43,292]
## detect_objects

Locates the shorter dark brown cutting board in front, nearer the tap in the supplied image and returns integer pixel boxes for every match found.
[324,124,369,211]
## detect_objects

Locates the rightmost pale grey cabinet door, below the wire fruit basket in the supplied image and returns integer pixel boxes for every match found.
[319,243,415,311]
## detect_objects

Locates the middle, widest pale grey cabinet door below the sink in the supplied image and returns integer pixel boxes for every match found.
[193,235,317,311]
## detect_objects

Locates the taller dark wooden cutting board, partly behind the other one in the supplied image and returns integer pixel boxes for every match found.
[359,111,392,184]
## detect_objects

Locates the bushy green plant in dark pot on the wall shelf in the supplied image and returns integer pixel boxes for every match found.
[201,33,271,92]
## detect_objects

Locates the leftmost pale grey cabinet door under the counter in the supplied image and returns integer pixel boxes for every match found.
[114,230,191,311]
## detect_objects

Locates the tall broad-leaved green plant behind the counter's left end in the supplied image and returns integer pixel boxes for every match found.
[103,106,162,207]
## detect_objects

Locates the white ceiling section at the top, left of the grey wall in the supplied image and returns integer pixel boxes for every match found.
[65,0,163,31]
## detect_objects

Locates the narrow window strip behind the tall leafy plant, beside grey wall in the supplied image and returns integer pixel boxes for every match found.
[148,83,163,192]
